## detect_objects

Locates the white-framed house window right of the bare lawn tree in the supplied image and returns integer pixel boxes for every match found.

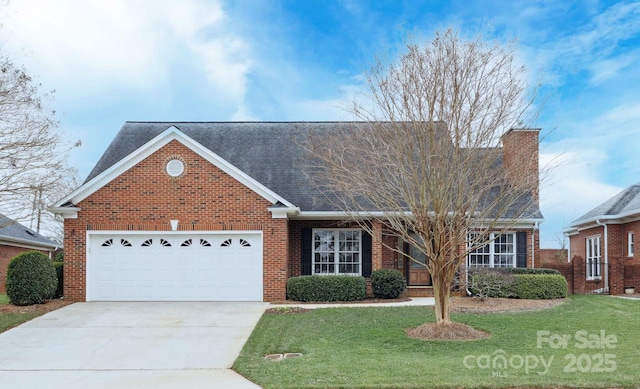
[467,233,516,267]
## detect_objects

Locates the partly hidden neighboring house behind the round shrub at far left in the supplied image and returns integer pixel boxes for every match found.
[0,214,60,293]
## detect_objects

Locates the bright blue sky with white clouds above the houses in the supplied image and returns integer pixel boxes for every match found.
[0,0,640,247]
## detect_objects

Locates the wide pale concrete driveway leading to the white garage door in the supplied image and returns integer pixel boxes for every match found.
[0,302,268,389]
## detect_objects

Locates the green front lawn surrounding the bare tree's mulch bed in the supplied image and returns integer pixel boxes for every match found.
[233,296,640,388]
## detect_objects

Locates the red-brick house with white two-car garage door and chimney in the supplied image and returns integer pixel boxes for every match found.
[52,122,542,301]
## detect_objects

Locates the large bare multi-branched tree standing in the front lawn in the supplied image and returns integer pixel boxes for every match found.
[305,30,538,324]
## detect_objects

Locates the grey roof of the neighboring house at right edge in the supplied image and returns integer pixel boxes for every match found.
[571,183,640,227]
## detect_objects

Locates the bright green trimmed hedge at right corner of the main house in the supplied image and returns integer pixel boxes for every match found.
[514,274,569,299]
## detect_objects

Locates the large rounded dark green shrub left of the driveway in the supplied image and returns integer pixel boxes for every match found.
[6,251,58,305]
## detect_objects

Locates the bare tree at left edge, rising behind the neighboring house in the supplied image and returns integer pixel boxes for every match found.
[0,57,79,230]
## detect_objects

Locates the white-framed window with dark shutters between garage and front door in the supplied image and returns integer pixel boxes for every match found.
[312,229,362,275]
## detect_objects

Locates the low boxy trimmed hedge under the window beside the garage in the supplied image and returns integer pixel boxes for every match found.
[287,276,367,301]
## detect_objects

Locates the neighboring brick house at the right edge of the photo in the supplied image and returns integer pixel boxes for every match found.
[565,183,640,294]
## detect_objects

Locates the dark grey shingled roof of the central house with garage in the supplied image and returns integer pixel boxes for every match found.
[79,122,542,218]
